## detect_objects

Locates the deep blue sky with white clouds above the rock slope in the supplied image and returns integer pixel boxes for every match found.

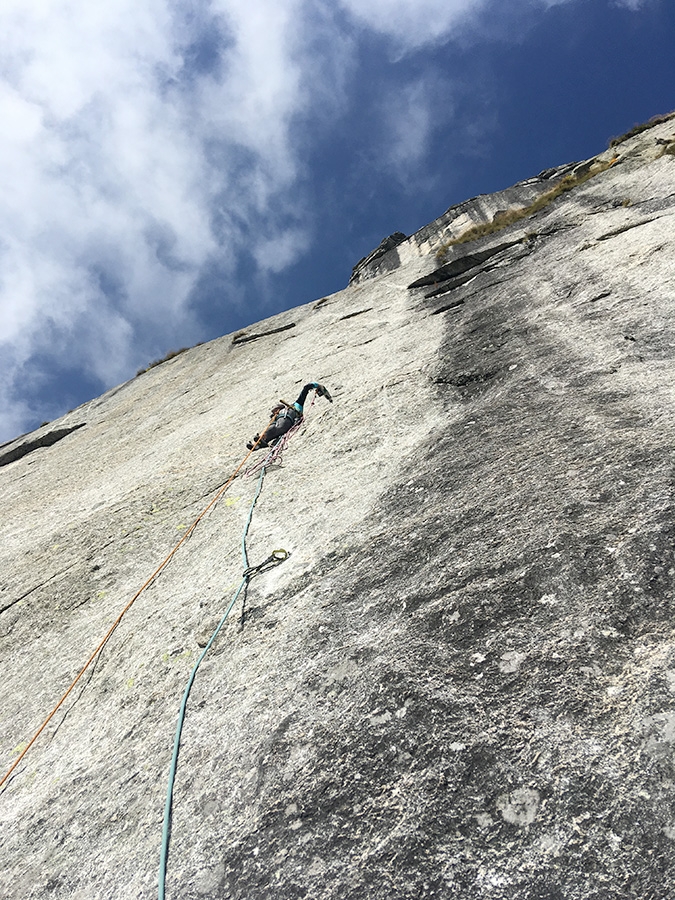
[0,0,675,442]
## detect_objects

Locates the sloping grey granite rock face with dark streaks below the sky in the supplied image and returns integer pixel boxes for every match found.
[0,122,675,900]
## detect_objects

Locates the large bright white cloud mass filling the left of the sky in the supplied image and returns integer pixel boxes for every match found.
[0,0,340,434]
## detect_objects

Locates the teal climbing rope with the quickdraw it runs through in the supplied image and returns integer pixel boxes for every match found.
[158,466,288,900]
